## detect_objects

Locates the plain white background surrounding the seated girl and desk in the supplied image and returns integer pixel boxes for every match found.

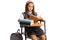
[0,0,60,40]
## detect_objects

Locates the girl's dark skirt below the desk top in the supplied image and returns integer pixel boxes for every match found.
[25,27,45,37]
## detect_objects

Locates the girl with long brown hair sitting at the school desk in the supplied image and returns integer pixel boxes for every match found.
[19,1,45,40]
